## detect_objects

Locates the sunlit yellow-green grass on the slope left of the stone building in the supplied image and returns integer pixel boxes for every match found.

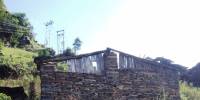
[0,47,40,98]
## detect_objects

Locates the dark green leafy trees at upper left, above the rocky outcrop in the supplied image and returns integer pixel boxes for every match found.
[0,0,33,47]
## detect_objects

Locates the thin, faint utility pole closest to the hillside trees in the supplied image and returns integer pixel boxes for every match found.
[44,20,54,47]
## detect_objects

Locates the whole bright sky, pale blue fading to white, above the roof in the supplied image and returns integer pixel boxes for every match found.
[4,0,200,67]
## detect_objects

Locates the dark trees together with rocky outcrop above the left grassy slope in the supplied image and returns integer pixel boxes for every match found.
[0,0,43,50]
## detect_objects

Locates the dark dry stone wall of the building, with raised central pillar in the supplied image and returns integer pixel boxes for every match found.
[40,51,180,100]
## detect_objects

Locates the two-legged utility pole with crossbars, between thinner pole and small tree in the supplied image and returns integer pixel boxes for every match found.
[57,30,65,54]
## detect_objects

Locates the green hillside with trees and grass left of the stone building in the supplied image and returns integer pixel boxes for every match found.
[0,0,45,99]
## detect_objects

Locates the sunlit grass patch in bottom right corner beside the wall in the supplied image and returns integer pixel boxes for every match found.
[179,82,200,100]
